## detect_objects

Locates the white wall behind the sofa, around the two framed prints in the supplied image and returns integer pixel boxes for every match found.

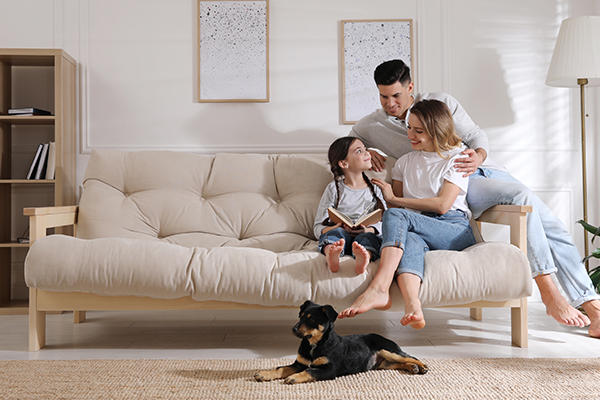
[0,0,600,272]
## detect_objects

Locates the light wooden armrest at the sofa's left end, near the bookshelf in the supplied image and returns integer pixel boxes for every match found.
[23,206,79,246]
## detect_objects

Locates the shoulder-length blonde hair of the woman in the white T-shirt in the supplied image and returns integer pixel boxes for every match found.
[410,99,462,157]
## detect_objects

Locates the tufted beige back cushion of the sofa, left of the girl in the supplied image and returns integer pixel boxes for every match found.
[77,150,384,252]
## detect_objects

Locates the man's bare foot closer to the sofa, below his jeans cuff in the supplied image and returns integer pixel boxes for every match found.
[535,275,590,328]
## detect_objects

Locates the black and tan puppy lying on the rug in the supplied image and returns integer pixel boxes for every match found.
[254,300,428,384]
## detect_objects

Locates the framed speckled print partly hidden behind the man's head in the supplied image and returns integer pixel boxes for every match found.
[341,19,415,125]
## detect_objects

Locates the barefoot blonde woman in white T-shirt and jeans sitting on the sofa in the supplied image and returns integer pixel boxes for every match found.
[339,100,475,329]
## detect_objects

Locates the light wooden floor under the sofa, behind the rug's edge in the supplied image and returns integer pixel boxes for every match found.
[0,301,600,360]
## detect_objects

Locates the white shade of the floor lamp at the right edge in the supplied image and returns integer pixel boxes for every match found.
[546,16,600,87]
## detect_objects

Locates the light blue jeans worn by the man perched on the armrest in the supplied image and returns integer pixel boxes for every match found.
[467,168,600,307]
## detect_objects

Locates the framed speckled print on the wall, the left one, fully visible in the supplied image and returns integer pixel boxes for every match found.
[198,0,269,103]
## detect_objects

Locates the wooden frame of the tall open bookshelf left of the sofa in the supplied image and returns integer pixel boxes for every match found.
[0,49,77,315]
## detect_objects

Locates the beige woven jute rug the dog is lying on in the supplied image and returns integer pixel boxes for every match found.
[0,358,600,400]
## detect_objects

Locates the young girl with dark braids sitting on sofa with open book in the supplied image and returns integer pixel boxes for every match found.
[314,137,385,274]
